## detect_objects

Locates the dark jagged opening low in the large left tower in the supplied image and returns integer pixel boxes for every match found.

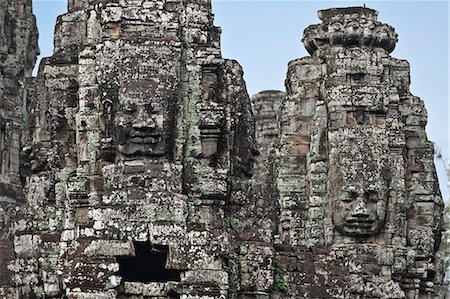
[117,242,181,282]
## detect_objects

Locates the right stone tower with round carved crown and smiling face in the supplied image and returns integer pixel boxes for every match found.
[272,7,443,298]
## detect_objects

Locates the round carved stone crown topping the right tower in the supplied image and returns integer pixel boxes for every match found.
[302,7,398,55]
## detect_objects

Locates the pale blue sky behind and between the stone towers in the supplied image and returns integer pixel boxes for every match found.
[33,0,450,201]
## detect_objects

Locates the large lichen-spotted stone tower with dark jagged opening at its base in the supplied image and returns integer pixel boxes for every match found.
[11,0,256,298]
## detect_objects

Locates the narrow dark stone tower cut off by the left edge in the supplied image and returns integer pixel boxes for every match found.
[0,0,39,298]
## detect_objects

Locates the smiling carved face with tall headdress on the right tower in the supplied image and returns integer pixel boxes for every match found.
[329,139,390,238]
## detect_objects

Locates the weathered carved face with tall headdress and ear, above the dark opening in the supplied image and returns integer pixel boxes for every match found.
[106,40,181,161]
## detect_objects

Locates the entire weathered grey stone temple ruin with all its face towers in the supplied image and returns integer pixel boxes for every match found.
[0,0,446,299]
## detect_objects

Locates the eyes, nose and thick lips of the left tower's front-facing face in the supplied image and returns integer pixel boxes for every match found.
[114,103,166,157]
